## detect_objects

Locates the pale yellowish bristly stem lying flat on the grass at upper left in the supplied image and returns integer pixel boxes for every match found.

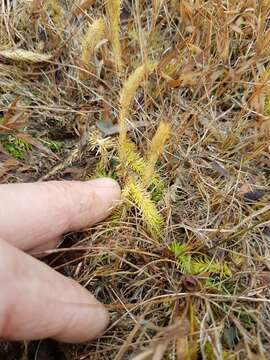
[0,49,52,63]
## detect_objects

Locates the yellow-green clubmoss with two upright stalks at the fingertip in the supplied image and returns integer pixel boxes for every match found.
[118,63,170,237]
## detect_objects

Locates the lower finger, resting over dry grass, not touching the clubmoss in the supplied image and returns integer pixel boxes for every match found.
[0,240,108,342]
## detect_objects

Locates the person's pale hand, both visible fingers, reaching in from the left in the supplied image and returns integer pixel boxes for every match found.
[0,179,120,342]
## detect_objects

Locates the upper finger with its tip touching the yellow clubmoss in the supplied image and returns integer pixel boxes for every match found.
[0,178,120,250]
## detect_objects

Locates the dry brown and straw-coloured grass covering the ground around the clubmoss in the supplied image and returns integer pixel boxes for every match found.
[0,0,270,360]
